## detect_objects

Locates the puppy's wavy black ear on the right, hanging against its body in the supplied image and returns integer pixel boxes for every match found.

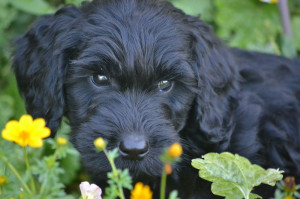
[188,17,238,143]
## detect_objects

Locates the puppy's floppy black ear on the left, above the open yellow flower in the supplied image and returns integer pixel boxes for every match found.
[13,7,80,136]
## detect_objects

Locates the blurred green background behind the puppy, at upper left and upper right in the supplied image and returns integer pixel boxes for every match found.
[0,0,300,130]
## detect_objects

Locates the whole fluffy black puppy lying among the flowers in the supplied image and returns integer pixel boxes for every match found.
[13,0,300,199]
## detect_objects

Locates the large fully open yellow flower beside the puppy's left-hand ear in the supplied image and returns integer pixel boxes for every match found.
[2,115,50,147]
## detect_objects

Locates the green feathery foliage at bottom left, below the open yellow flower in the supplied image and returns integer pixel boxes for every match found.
[0,119,80,199]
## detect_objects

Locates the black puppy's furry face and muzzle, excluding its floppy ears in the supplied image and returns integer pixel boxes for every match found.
[65,3,197,176]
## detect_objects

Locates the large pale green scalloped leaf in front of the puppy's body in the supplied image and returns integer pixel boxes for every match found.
[192,152,282,199]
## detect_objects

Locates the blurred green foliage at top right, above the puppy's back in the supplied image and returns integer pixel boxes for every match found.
[170,0,300,57]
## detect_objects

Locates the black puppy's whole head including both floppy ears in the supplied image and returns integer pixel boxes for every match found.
[13,0,239,179]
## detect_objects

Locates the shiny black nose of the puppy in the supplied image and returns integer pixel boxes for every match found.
[119,135,149,159]
